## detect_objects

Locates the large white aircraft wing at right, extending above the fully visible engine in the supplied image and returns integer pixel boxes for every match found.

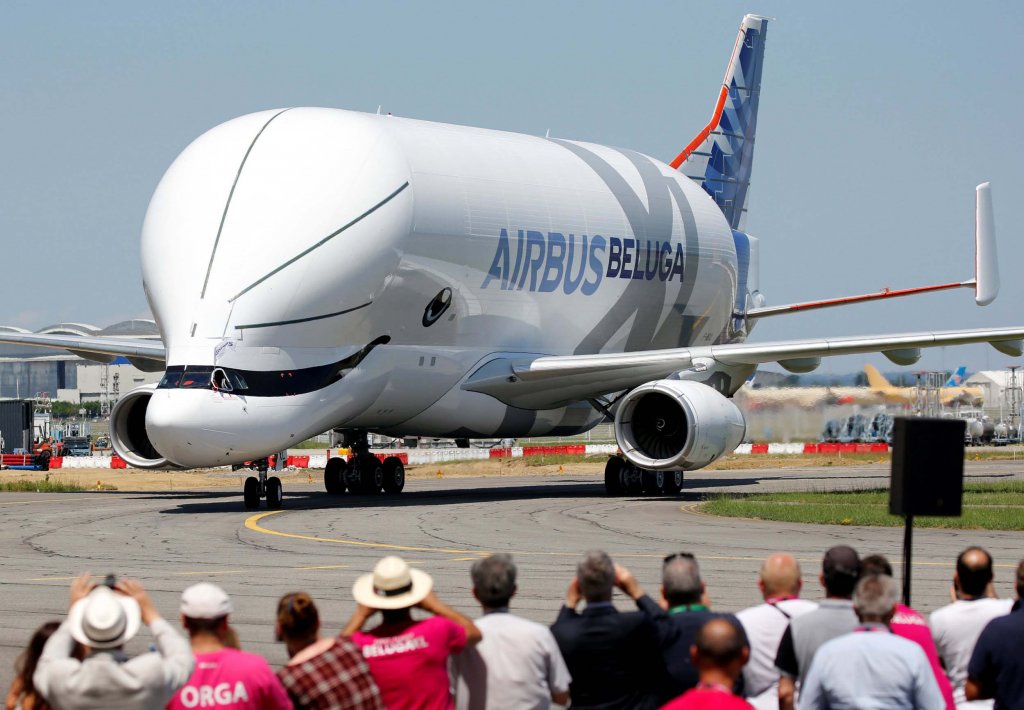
[462,327,1024,409]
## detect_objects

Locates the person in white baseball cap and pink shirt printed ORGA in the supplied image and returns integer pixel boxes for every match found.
[167,582,292,710]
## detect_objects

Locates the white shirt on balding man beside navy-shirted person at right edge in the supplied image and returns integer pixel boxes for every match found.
[928,596,1014,708]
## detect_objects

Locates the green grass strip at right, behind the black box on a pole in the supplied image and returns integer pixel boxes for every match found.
[701,481,1024,530]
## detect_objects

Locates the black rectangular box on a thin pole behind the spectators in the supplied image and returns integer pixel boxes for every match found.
[889,417,967,607]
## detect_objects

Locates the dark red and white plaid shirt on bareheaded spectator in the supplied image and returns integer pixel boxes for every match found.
[278,637,384,710]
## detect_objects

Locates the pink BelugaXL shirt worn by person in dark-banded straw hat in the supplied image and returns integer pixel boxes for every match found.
[352,617,466,710]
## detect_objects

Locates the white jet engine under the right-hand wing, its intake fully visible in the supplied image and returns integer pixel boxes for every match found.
[615,380,746,470]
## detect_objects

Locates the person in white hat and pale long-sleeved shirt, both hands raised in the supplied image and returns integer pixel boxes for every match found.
[32,573,193,710]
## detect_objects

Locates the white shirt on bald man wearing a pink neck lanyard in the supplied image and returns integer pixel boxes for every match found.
[736,599,818,710]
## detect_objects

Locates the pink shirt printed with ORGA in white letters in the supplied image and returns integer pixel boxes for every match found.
[167,649,292,710]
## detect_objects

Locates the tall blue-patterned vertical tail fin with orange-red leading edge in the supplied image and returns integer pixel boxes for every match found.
[672,14,768,231]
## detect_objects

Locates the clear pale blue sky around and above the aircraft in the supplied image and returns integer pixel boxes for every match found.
[0,0,1024,371]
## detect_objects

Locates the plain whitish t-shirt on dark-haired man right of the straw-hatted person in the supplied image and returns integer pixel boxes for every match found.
[454,612,571,710]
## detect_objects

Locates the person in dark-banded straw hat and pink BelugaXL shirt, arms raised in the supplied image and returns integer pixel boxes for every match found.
[342,557,482,710]
